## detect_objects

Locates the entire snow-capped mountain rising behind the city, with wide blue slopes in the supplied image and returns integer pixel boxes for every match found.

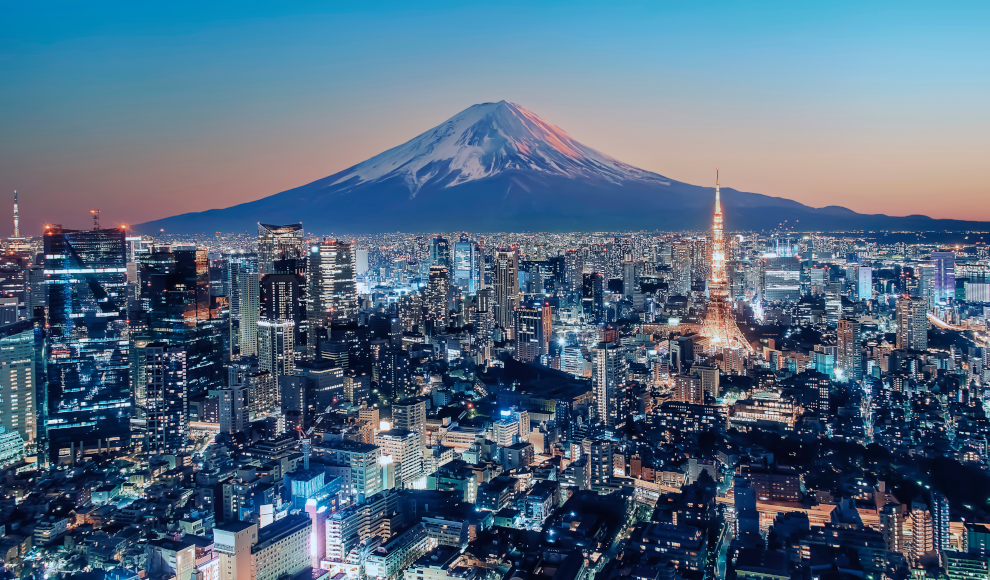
[136,101,986,233]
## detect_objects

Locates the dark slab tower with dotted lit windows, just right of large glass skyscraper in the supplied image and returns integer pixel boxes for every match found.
[144,342,189,453]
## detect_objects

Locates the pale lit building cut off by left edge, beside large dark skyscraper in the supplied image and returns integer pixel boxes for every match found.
[0,320,45,451]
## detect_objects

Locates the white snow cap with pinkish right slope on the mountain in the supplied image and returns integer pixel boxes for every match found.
[326,101,669,196]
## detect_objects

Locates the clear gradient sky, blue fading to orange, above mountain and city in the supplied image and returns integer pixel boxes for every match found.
[0,0,990,235]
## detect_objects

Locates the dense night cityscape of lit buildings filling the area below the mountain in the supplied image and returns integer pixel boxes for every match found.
[0,188,990,580]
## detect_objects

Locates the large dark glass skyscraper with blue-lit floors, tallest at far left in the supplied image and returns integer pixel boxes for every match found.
[44,226,131,461]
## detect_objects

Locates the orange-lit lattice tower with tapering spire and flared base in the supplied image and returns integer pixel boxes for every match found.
[701,176,750,350]
